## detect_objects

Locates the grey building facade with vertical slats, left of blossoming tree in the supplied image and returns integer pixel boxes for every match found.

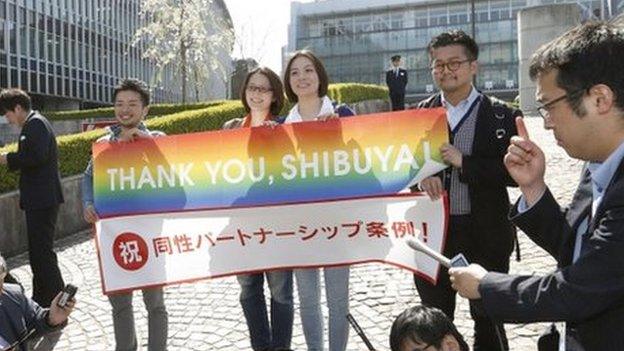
[0,0,232,107]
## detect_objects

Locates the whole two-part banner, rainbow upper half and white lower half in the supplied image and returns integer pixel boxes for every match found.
[93,109,448,293]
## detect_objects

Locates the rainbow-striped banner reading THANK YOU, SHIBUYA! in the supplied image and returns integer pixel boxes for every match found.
[93,108,448,218]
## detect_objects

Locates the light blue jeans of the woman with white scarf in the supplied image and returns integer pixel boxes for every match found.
[295,266,349,351]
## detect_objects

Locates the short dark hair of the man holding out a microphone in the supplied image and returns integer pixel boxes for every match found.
[529,21,624,116]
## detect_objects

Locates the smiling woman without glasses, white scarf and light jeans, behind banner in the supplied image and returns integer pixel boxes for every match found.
[284,50,354,351]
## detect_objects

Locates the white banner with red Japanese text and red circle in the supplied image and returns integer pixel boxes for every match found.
[96,193,448,294]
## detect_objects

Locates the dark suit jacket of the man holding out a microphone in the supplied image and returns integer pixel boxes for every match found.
[479,161,624,350]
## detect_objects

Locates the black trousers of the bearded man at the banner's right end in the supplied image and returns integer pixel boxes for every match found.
[414,215,509,351]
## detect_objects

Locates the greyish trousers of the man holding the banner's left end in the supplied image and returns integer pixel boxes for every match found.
[108,288,168,351]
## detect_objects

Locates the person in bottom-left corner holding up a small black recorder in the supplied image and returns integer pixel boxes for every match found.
[0,256,75,351]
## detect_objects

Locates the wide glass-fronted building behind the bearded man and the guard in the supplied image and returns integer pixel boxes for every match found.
[290,0,600,96]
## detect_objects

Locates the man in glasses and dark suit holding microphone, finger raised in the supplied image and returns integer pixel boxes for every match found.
[451,22,624,350]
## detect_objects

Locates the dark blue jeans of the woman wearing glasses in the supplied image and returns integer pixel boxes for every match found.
[236,271,294,351]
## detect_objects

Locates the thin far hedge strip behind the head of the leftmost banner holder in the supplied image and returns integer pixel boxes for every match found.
[42,100,225,121]
